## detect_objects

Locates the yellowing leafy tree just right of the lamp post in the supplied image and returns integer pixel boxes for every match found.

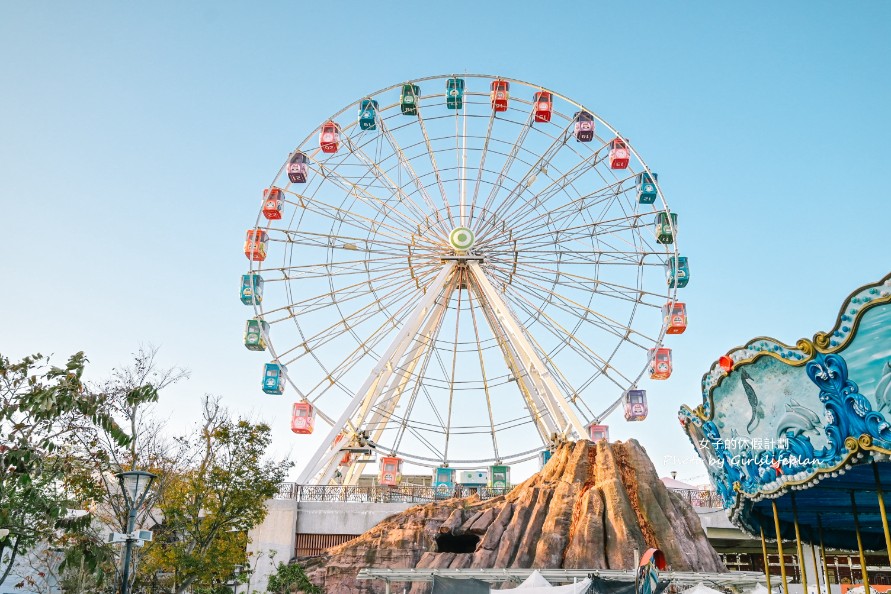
[141,396,291,594]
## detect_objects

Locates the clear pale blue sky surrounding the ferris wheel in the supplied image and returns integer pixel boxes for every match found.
[0,1,891,479]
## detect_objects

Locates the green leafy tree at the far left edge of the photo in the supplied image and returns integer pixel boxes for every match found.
[0,353,134,584]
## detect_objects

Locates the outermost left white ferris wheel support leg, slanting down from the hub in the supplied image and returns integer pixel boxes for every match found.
[297,262,455,484]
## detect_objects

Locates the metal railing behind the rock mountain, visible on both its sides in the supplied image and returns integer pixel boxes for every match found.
[276,483,724,508]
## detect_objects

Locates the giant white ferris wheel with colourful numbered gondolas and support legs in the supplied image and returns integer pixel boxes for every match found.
[241,74,689,484]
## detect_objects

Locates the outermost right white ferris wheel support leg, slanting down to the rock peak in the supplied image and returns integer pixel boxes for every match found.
[467,261,585,437]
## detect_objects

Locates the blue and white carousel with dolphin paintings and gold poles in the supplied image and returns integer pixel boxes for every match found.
[679,275,891,592]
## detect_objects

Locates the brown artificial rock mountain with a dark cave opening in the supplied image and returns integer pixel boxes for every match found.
[306,440,726,594]
